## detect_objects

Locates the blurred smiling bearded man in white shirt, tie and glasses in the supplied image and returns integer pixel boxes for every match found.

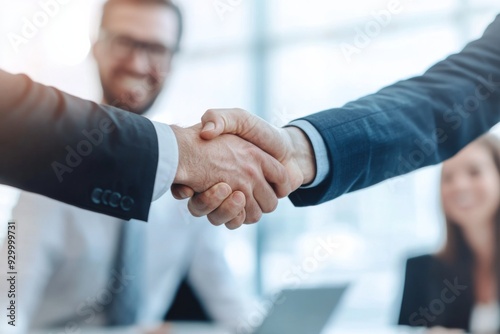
[0,0,247,331]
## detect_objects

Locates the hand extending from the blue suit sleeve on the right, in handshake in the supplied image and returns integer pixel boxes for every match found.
[172,109,316,228]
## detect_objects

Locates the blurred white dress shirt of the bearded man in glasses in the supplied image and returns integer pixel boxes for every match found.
[0,193,248,333]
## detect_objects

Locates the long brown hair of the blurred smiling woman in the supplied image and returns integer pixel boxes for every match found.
[436,134,500,264]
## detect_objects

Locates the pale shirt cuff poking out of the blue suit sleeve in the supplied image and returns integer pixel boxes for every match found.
[287,119,330,189]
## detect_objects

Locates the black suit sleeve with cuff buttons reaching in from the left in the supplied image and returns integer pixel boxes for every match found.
[0,70,158,220]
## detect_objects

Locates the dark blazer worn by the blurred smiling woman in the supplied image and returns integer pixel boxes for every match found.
[398,255,474,330]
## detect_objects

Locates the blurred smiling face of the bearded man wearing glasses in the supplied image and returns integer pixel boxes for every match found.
[94,3,178,114]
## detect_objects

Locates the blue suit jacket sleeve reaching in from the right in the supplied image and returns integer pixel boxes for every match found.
[290,16,500,206]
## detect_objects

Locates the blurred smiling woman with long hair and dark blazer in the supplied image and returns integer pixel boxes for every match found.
[399,134,500,333]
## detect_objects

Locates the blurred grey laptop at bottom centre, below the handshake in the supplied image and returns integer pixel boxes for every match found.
[253,285,347,334]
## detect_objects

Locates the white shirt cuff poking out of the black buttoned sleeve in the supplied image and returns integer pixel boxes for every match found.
[153,121,179,201]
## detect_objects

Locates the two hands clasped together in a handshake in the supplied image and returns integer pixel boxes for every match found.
[172,109,316,229]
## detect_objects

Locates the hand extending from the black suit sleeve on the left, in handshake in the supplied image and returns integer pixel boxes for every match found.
[172,124,291,228]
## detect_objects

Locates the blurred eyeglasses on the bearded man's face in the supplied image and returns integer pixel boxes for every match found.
[102,33,175,68]
